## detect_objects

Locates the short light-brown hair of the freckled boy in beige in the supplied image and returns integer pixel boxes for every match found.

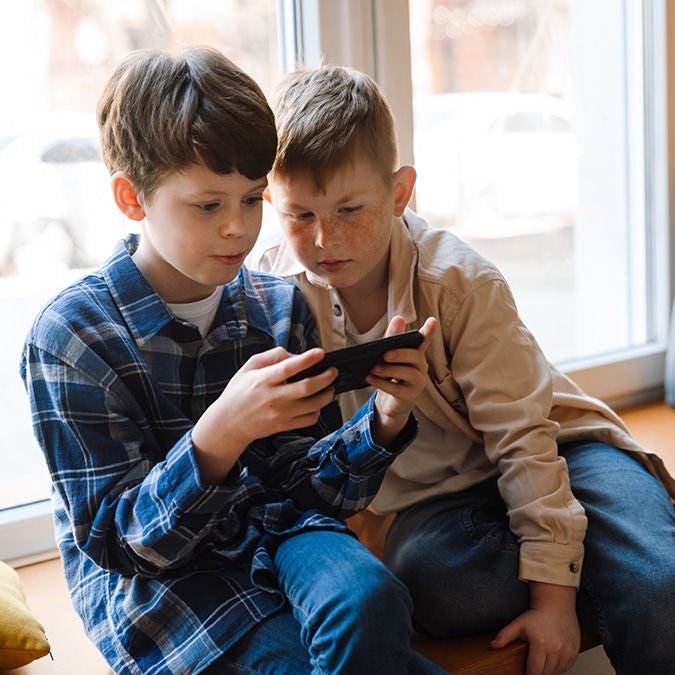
[273,66,398,189]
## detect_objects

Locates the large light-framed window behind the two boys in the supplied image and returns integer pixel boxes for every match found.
[0,0,672,559]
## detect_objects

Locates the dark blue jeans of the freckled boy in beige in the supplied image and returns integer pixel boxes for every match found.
[385,442,675,675]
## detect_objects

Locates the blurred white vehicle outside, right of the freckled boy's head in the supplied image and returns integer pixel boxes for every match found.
[414,93,579,237]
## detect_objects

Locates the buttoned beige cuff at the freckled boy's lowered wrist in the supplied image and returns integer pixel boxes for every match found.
[518,542,584,589]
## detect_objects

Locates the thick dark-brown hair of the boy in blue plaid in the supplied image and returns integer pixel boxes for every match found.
[96,47,277,195]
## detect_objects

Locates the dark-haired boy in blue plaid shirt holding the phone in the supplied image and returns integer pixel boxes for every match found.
[21,48,440,675]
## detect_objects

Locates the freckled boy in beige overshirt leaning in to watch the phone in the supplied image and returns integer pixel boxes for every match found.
[258,67,675,675]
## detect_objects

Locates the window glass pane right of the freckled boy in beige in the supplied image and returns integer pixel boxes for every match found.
[410,0,646,362]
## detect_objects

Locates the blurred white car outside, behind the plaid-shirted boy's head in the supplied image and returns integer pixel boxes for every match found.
[0,113,129,274]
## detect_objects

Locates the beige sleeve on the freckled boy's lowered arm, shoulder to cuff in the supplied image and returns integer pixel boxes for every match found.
[445,278,586,586]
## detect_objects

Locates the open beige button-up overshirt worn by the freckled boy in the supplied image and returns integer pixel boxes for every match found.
[255,210,675,587]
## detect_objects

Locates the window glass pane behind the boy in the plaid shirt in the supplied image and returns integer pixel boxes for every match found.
[0,0,279,509]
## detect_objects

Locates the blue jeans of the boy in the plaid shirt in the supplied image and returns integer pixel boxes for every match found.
[205,531,446,675]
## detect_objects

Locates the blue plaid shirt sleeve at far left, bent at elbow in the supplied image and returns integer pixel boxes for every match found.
[22,336,262,575]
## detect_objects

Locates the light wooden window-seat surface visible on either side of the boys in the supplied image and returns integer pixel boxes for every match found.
[9,404,675,675]
